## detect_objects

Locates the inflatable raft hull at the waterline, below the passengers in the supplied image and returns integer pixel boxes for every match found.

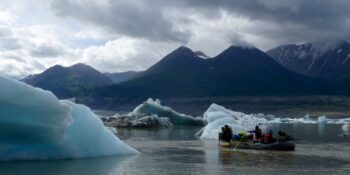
[220,141,295,151]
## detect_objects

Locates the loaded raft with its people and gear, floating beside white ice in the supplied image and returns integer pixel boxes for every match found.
[219,125,295,151]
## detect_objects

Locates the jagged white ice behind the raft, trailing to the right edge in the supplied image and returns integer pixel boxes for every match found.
[196,104,350,140]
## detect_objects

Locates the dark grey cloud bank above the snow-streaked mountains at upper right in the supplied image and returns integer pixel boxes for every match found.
[183,0,350,42]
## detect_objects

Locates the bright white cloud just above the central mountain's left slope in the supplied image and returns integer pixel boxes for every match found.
[82,37,178,72]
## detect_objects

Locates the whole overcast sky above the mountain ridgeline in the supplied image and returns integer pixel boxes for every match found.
[0,0,350,76]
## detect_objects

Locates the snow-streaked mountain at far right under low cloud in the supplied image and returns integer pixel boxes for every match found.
[267,41,350,80]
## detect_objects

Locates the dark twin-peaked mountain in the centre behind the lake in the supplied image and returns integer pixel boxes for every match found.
[89,46,324,103]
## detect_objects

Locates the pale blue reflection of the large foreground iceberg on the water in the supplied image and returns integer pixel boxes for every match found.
[0,156,133,175]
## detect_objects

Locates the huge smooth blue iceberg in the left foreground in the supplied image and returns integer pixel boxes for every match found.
[0,76,137,160]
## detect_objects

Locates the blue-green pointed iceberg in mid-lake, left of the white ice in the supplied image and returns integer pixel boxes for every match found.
[133,98,206,125]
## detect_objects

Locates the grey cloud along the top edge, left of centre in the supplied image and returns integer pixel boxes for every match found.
[52,0,188,42]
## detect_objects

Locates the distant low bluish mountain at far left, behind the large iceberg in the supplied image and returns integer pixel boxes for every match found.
[22,63,113,98]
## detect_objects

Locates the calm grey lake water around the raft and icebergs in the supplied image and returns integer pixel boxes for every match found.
[0,124,350,175]
